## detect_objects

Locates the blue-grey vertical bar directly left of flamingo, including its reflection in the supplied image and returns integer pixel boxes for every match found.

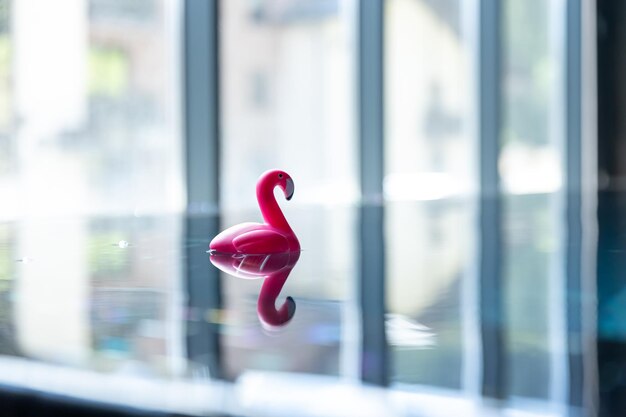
[184,0,222,378]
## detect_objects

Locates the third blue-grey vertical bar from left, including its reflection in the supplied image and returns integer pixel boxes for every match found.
[478,0,506,398]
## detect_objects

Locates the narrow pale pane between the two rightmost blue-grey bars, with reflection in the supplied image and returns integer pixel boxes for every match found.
[499,0,566,398]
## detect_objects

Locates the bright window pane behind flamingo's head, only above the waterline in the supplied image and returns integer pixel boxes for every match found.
[220,0,358,209]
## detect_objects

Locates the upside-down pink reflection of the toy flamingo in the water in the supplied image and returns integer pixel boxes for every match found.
[210,251,300,330]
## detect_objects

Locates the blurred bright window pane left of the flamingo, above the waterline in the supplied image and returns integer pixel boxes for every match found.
[8,0,184,217]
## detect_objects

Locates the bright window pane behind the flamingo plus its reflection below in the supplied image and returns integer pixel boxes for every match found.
[220,0,358,378]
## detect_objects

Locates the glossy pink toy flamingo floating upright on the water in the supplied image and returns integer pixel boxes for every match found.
[209,170,300,254]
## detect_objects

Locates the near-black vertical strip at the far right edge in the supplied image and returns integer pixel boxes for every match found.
[596,0,626,417]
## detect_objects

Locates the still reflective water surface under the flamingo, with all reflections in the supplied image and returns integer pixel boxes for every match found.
[0,194,626,416]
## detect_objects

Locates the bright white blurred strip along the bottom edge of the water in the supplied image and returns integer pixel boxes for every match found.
[0,357,575,417]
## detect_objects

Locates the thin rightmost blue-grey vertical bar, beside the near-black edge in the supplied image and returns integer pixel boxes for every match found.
[565,0,584,407]
